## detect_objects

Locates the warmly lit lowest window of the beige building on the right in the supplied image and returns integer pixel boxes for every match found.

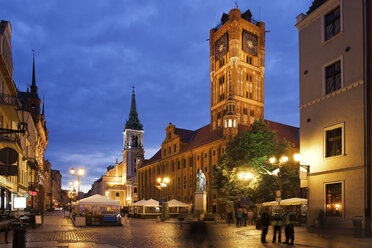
[325,183,343,217]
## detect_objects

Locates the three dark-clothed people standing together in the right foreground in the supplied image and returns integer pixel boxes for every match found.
[261,208,296,245]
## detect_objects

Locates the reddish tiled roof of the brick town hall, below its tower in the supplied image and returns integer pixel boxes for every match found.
[143,120,299,166]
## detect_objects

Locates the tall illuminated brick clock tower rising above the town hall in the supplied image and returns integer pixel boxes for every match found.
[210,9,265,136]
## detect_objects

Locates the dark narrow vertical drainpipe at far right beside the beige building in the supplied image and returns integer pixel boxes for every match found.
[363,0,371,236]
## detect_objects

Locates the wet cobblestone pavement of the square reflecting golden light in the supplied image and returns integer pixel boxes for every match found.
[0,212,372,248]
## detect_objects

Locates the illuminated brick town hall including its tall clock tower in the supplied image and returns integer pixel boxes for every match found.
[137,9,299,212]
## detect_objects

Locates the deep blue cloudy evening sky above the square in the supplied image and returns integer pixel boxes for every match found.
[0,0,312,191]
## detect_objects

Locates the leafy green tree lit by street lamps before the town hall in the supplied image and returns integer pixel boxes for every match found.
[213,119,299,202]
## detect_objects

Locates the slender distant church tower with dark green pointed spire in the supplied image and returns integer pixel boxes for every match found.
[123,87,144,178]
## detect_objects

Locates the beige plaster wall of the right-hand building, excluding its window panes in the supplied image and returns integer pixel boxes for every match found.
[296,0,364,225]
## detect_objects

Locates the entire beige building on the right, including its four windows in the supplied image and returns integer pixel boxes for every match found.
[296,0,371,230]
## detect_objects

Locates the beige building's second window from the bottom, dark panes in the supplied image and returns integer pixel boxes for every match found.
[325,126,343,158]
